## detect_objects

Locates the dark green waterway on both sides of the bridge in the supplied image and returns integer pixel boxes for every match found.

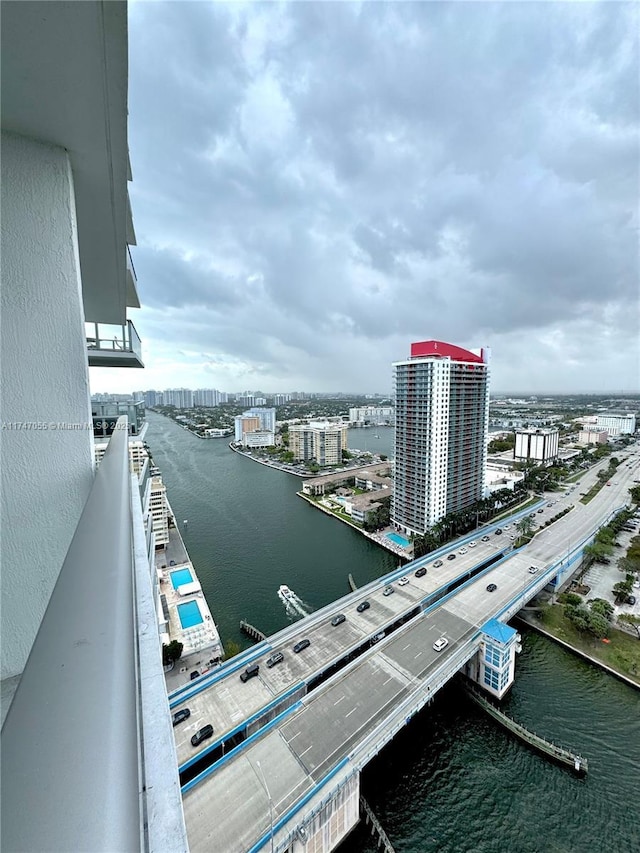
[147,412,640,853]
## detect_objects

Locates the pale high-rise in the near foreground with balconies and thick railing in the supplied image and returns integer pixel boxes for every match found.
[0,1,188,853]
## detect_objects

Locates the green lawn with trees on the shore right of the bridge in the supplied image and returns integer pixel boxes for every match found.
[540,604,640,684]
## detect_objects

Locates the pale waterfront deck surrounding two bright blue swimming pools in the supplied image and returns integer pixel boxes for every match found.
[155,510,223,690]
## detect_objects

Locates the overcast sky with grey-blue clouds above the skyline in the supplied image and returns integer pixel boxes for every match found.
[87,2,640,393]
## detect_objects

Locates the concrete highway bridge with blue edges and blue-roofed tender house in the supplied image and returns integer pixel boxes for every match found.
[169,454,638,853]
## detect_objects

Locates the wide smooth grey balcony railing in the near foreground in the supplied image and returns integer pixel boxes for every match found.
[1,417,188,853]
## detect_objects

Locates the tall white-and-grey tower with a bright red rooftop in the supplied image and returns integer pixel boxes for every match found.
[392,341,489,534]
